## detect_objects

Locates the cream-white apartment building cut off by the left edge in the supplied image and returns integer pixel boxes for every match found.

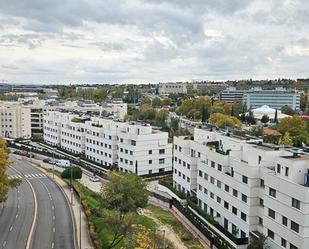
[0,102,31,138]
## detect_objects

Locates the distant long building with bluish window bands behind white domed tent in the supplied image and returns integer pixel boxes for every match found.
[243,88,300,111]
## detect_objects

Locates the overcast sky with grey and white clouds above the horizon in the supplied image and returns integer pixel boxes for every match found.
[0,0,309,84]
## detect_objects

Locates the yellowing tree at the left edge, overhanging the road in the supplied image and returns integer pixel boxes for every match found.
[0,139,21,203]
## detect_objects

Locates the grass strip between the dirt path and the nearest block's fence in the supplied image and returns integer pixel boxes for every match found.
[147,205,204,249]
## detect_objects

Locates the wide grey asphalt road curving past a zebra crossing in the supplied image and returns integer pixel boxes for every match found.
[0,155,74,249]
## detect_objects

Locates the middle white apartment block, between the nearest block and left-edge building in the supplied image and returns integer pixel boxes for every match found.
[44,111,172,175]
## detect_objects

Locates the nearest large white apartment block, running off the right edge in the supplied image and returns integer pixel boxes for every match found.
[173,129,309,249]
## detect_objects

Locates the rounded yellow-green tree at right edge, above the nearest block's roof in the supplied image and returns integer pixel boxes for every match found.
[277,116,308,137]
